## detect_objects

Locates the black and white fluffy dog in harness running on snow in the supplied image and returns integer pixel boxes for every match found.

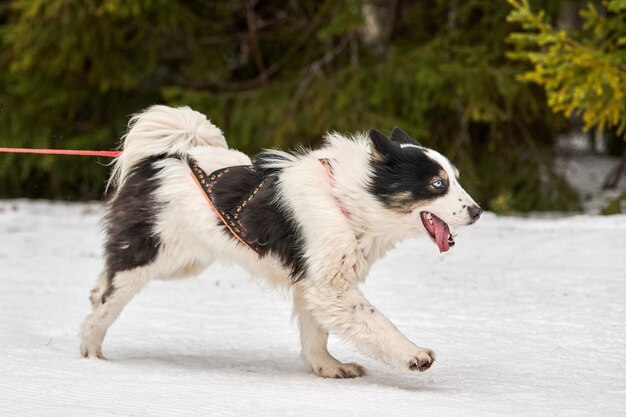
[81,106,482,378]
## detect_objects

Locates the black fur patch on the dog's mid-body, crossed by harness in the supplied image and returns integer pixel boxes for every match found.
[211,154,305,282]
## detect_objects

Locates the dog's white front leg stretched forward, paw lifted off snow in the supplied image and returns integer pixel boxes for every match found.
[301,281,435,371]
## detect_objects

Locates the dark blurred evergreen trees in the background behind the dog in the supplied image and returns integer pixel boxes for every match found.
[0,0,578,212]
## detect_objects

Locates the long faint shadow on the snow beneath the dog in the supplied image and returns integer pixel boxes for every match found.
[109,349,446,392]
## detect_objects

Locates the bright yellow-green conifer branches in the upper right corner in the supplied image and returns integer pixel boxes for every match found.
[508,0,626,135]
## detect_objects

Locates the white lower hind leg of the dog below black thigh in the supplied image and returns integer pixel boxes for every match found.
[80,265,154,359]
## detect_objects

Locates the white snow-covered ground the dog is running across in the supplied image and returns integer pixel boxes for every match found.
[0,201,626,417]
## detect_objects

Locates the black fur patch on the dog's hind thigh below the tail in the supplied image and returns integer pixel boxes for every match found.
[102,155,168,303]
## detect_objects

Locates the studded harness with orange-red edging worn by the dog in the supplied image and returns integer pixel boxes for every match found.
[188,158,350,257]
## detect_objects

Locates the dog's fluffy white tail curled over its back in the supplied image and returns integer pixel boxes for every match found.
[107,105,228,189]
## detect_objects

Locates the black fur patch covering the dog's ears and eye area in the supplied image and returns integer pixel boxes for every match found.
[369,128,448,208]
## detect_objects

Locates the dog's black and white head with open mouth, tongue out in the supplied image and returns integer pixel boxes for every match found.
[370,128,482,252]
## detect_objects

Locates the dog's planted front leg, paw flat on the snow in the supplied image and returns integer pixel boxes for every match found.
[293,285,367,378]
